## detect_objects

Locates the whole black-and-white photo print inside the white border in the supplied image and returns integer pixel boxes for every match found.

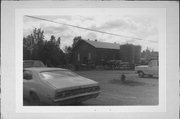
[23,14,159,106]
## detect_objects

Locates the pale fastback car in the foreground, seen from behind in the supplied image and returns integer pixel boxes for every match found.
[23,67,100,105]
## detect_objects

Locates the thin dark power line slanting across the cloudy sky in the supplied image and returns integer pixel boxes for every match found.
[25,15,158,42]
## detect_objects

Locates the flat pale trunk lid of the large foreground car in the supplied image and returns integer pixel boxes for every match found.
[42,76,98,89]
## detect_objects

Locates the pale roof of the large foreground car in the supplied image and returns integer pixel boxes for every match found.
[24,67,68,72]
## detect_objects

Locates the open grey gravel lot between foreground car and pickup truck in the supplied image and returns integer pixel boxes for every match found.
[24,70,158,106]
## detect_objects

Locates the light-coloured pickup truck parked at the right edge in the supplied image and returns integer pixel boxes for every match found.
[135,60,159,78]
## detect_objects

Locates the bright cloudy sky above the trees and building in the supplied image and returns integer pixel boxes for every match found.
[23,15,158,51]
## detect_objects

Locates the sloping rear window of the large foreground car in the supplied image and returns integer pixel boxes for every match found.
[40,70,78,79]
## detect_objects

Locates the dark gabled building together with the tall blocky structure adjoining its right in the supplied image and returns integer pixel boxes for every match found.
[73,40,141,67]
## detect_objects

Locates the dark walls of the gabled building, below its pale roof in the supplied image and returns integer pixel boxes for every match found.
[73,41,119,65]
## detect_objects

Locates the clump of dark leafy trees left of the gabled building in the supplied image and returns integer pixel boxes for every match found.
[23,28,64,67]
